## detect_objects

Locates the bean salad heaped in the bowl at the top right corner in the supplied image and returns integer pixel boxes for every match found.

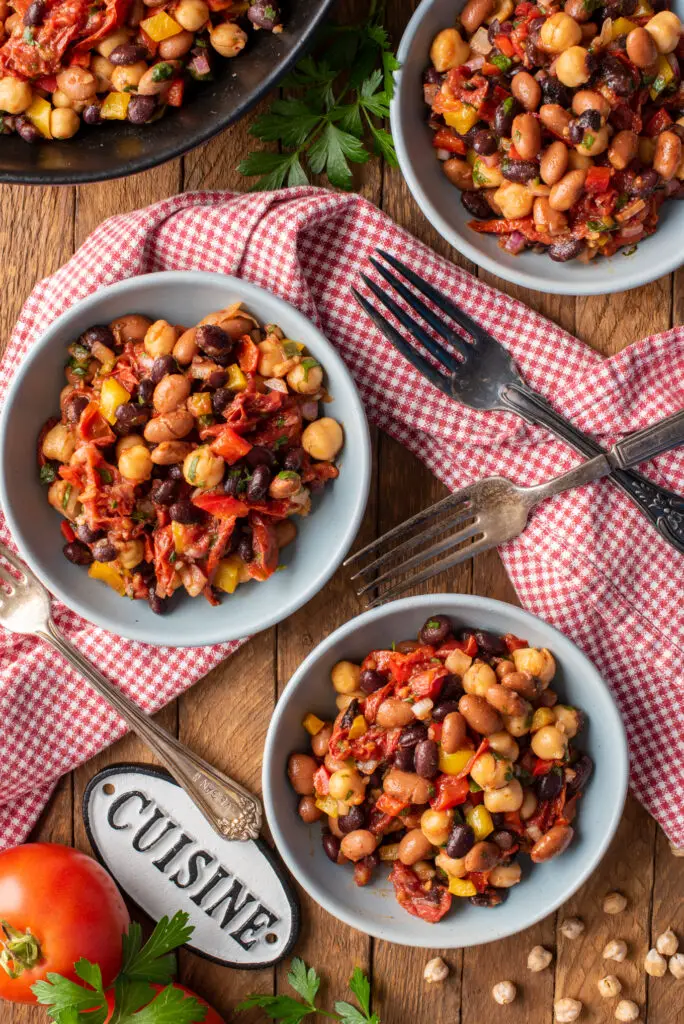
[423,0,684,262]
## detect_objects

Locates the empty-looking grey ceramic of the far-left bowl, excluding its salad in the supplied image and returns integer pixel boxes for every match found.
[0,271,371,647]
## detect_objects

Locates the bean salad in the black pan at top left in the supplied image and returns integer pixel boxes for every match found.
[0,0,283,142]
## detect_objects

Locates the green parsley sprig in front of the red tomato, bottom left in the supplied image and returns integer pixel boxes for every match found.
[33,911,201,1024]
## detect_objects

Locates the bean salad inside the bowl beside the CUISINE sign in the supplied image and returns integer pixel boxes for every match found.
[288,614,593,923]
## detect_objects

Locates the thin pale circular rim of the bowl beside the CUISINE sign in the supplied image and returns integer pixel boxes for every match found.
[261,594,630,949]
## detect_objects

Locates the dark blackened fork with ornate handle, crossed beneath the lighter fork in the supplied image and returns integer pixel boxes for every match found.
[351,249,684,553]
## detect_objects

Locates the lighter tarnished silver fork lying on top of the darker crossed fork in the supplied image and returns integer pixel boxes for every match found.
[344,410,684,608]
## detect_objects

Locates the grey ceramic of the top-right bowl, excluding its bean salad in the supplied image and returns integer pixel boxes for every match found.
[390,0,684,295]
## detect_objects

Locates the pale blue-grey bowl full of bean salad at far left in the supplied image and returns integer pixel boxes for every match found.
[0,271,370,646]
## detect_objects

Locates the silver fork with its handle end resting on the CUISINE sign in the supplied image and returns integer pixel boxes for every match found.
[0,544,262,841]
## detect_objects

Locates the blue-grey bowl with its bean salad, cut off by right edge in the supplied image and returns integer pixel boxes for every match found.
[391,0,684,295]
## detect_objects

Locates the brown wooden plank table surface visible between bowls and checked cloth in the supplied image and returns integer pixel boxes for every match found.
[0,0,684,1024]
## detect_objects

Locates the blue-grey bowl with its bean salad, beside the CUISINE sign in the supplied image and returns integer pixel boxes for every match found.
[263,594,628,948]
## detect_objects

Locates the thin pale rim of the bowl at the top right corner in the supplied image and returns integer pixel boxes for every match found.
[389,0,683,296]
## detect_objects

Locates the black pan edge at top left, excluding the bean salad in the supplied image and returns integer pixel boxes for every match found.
[0,0,333,185]
